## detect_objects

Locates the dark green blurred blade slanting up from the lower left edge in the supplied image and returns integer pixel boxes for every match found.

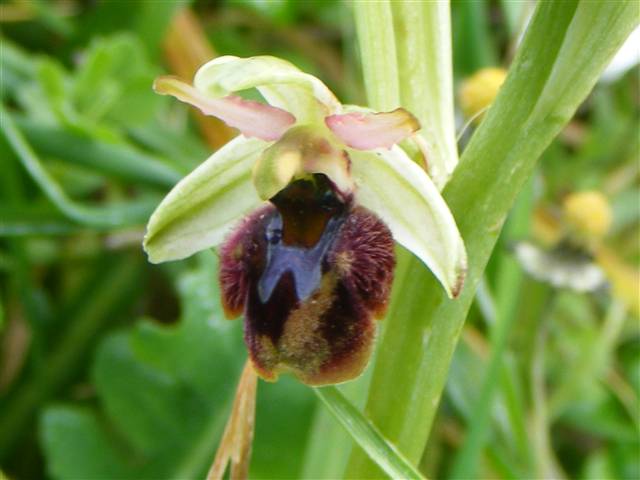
[0,255,144,461]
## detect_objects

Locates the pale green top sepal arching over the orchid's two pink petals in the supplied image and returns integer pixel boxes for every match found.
[193,55,340,123]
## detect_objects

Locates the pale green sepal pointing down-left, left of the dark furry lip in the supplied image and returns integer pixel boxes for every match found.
[144,136,269,263]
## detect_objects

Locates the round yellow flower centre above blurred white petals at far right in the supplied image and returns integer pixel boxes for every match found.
[562,191,612,240]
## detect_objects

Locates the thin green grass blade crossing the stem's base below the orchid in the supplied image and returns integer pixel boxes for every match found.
[314,387,424,479]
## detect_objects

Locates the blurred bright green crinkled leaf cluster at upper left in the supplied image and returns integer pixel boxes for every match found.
[8,34,164,139]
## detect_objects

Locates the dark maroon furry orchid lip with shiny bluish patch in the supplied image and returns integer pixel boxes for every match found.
[220,174,395,385]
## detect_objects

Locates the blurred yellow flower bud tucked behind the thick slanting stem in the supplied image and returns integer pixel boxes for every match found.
[458,67,507,122]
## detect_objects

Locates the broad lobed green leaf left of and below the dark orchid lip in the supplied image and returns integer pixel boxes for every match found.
[41,253,243,478]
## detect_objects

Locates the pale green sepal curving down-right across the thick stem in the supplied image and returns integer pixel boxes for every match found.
[349,146,467,297]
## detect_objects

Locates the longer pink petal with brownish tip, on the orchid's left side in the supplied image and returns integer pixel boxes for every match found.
[153,76,296,141]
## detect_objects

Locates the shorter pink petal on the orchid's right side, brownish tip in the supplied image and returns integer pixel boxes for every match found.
[324,108,420,150]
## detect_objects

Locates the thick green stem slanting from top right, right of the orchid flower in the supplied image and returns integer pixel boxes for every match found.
[349,1,638,478]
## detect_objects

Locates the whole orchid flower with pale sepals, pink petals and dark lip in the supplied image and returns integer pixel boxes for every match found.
[144,56,466,385]
